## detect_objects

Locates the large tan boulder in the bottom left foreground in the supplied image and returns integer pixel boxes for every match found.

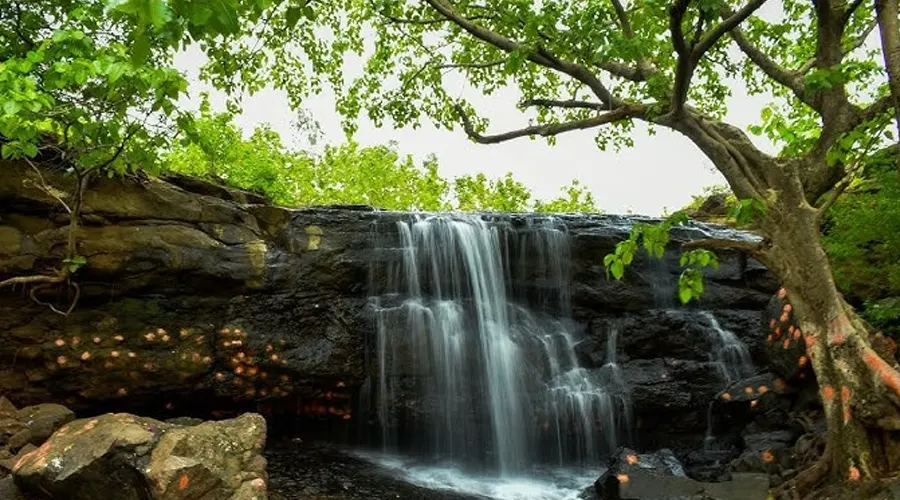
[13,414,267,500]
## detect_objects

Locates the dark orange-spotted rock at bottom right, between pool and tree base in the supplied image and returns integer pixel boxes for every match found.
[582,448,769,500]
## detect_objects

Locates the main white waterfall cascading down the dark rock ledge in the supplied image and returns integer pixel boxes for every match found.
[370,215,629,473]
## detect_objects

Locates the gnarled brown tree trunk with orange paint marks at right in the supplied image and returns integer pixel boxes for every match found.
[761,182,900,490]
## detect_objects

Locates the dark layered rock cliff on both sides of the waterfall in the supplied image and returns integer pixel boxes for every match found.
[0,162,776,446]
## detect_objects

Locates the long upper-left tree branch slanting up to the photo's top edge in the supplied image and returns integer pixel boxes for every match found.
[425,0,624,108]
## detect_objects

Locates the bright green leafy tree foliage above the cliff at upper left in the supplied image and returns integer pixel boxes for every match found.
[0,0,270,173]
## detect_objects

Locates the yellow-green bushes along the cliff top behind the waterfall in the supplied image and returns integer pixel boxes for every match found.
[166,96,599,212]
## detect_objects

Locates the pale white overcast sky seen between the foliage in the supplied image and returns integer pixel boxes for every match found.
[176,33,780,215]
